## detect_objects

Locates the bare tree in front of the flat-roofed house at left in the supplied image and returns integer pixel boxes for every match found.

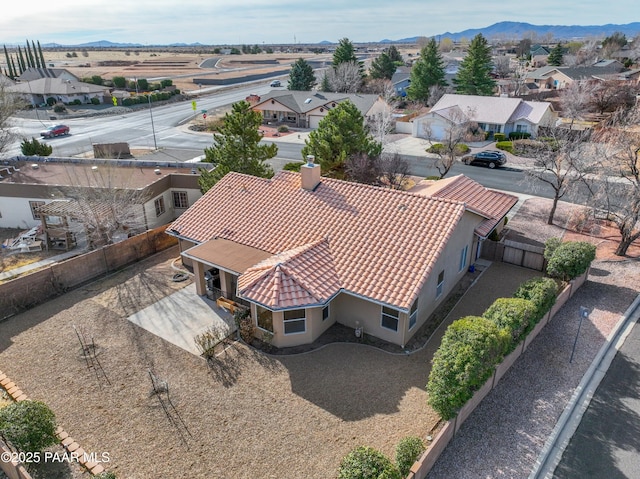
[60,163,150,249]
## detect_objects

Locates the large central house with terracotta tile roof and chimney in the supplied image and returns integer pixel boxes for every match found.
[167,163,517,347]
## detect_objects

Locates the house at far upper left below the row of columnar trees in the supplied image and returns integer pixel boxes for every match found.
[5,77,111,106]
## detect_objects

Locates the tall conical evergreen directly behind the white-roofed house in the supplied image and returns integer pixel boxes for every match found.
[453,33,496,96]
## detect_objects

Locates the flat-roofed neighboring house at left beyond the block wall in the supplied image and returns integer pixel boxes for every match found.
[0,157,202,235]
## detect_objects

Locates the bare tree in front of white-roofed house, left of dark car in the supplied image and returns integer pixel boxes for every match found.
[423,107,484,178]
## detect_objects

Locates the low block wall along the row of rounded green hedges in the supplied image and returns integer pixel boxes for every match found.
[407,270,589,479]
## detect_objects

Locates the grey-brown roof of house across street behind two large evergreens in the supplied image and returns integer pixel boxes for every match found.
[252,90,379,115]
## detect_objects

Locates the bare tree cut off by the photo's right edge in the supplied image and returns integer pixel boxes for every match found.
[594,106,640,256]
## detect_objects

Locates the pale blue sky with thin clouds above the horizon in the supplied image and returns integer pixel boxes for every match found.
[0,0,638,45]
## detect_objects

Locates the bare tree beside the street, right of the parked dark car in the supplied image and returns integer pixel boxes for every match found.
[525,128,593,225]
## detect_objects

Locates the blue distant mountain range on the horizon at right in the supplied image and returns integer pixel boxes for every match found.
[396,22,640,43]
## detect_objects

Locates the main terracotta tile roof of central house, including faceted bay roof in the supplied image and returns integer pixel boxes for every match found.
[167,171,465,310]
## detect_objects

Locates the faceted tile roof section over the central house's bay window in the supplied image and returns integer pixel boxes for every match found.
[238,239,341,309]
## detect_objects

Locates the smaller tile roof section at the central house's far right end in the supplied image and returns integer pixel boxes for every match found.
[411,175,518,238]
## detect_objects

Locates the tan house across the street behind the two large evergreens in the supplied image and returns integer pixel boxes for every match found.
[252,90,389,129]
